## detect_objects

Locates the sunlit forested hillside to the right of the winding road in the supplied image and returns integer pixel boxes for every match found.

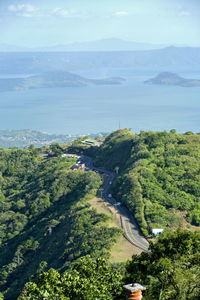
[93,129,200,235]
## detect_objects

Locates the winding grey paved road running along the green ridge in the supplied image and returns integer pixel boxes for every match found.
[82,156,149,251]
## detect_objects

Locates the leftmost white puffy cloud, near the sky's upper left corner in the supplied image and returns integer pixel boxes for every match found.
[8,4,38,17]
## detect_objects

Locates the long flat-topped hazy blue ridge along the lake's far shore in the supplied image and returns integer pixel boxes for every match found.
[0,47,200,74]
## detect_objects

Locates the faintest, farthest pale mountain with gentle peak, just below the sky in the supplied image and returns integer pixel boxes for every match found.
[0,38,166,52]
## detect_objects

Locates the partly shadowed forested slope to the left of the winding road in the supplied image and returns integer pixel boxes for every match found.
[0,149,119,300]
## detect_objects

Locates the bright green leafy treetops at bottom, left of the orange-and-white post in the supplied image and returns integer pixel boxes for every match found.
[18,257,123,300]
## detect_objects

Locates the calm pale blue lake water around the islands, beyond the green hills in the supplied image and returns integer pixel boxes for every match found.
[0,72,200,134]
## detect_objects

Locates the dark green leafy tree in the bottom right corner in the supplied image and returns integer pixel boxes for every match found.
[126,230,200,300]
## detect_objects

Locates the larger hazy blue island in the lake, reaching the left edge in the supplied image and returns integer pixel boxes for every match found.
[0,71,125,92]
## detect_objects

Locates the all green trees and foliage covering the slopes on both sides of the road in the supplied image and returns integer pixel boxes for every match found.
[0,129,200,300]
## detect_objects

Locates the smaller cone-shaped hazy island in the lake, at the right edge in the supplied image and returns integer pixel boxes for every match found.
[144,72,200,87]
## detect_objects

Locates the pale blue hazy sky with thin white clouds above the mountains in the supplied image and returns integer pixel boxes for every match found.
[0,0,200,47]
